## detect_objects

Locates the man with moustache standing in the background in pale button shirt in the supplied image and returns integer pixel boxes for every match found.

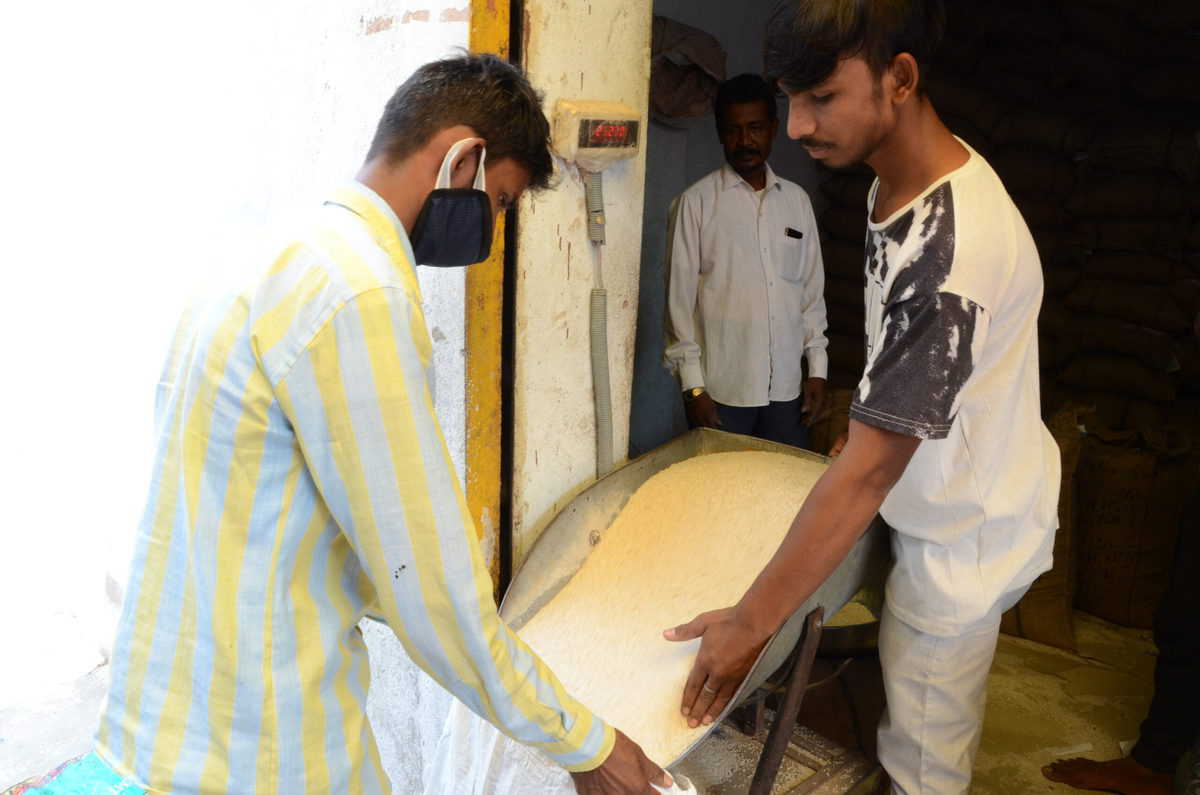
[666,74,828,447]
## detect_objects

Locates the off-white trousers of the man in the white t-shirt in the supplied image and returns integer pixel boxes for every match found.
[878,587,1027,795]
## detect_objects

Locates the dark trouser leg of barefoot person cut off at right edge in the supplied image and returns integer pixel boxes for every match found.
[1130,492,1200,773]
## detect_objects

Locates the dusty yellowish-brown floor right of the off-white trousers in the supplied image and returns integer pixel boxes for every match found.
[971,612,1154,795]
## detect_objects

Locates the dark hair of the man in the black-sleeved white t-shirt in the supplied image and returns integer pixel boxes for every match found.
[763,0,946,92]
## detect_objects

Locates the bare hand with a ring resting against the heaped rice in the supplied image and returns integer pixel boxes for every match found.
[662,608,770,728]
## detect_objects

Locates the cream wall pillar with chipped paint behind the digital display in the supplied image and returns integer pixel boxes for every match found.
[512,0,650,567]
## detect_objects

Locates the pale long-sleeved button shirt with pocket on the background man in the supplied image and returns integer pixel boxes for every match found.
[666,165,829,406]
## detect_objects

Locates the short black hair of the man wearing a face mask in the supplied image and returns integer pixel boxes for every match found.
[367,53,554,190]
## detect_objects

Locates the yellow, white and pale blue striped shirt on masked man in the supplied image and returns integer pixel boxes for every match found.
[96,184,613,795]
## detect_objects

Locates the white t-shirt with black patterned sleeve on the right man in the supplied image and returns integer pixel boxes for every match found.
[850,144,1060,635]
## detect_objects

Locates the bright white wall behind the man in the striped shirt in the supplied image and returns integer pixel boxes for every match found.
[0,0,469,791]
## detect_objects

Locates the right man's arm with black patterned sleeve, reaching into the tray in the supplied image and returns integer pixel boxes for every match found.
[667,285,989,724]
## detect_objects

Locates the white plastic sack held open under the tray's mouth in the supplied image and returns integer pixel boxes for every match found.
[425,701,702,795]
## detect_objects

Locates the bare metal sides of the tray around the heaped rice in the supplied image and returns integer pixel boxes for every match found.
[500,429,890,765]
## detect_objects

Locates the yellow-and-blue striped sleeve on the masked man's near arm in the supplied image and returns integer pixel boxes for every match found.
[276,288,657,791]
